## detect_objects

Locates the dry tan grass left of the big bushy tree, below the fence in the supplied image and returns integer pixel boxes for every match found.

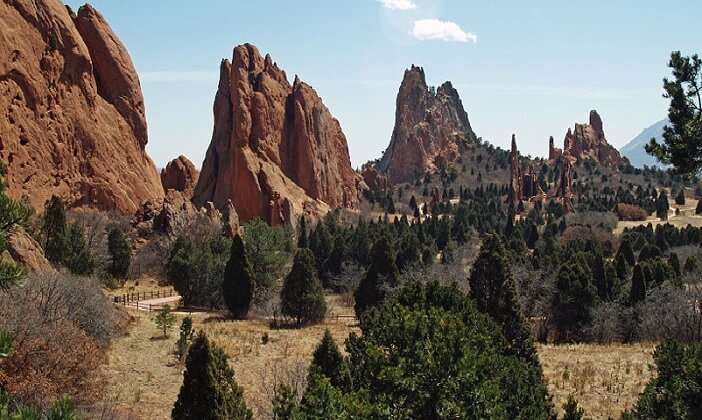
[105,296,358,419]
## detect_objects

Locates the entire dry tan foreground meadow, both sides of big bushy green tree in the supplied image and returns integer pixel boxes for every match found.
[105,295,654,419]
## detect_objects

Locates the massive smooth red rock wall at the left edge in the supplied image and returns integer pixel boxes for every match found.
[0,0,163,213]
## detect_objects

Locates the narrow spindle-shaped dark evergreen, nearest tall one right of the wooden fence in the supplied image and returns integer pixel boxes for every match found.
[222,235,254,319]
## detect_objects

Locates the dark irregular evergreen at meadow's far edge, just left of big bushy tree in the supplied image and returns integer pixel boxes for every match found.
[354,235,399,318]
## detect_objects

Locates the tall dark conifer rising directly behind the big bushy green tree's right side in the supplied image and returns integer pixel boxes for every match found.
[469,235,539,365]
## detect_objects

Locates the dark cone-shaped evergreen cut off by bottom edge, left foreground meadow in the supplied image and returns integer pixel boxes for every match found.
[171,332,253,420]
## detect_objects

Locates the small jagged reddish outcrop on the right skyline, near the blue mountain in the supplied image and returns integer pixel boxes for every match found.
[560,110,625,168]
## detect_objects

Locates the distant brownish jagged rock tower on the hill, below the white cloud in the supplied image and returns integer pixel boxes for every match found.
[378,65,476,183]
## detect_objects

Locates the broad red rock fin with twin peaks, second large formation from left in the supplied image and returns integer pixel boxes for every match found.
[193,44,360,224]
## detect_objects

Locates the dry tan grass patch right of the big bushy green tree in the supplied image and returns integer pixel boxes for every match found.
[537,344,655,419]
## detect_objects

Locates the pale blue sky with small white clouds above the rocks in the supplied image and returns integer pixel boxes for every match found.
[66,0,702,167]
